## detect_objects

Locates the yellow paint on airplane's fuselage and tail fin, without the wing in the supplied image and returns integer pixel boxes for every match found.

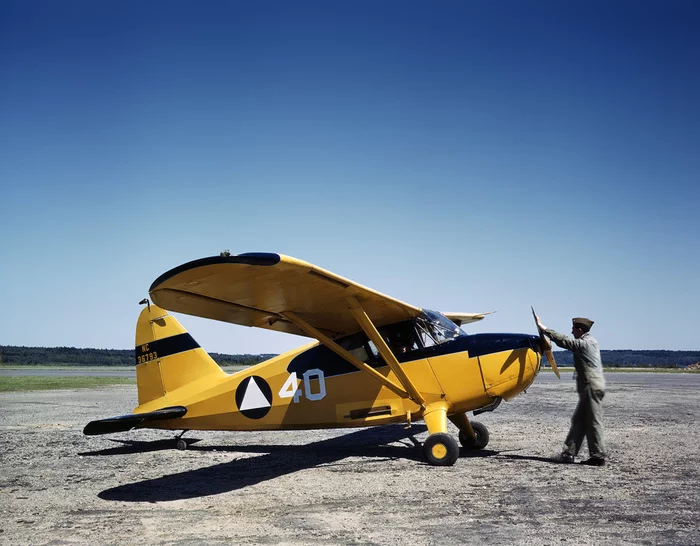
[129,305,539,434]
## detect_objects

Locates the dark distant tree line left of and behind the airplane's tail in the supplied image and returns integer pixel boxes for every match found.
[0,345,275,366]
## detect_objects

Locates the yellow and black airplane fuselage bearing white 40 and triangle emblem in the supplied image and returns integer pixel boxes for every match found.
[135,312,540,430]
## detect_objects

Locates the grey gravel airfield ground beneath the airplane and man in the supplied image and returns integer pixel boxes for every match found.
[0,372,700,545]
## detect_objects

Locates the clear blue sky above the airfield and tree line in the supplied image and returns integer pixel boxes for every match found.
[0,0,700,353]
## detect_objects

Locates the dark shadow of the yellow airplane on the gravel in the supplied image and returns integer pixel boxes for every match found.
[93,425,508,502]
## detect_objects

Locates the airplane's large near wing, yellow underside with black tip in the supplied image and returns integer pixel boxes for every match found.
[149,253,421,337]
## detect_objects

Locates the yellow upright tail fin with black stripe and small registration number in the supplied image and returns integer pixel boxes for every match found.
[136,304,227,411]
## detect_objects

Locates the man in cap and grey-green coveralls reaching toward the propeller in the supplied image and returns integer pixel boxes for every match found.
[535,316,605,466]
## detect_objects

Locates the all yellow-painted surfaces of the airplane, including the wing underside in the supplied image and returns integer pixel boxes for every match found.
[90,256,539,444]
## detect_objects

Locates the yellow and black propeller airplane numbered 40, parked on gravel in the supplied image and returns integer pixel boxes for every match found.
[83,251,559,466]
